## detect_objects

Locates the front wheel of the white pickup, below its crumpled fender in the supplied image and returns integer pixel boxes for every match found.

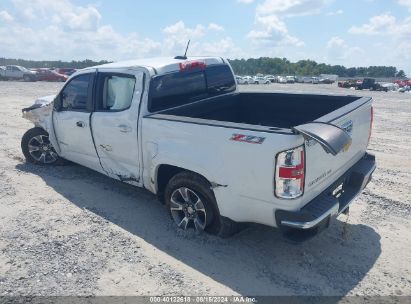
[21,128,64,165]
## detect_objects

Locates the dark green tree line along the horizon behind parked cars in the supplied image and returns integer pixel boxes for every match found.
[0,57,406,78]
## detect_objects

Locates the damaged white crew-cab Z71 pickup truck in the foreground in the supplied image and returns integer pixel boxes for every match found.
[21,57,375,241]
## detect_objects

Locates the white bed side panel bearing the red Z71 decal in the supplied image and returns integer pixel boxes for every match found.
[142,117,304,226]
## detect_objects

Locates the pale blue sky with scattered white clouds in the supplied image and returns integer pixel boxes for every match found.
[0,0,411,75]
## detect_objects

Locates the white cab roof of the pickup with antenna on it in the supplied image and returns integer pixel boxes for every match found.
[84,56,226,75]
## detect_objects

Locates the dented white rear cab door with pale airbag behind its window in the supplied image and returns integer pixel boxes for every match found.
[91,70,144,185]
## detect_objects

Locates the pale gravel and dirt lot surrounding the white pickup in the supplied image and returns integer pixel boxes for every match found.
[0,82,411,296]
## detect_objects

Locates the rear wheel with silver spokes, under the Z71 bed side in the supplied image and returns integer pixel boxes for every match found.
[164,171,238,238]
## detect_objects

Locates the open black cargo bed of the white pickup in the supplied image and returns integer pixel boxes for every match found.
[150,92,363,130]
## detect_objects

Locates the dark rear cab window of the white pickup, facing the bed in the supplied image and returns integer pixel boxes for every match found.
[148,64,236,112]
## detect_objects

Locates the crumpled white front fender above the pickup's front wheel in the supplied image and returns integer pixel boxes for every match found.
[22,95,60,154]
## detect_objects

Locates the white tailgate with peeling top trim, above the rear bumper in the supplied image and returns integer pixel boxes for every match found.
[293,97,372,199]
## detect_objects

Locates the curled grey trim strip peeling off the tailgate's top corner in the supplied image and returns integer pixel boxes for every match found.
[292,122,352,155]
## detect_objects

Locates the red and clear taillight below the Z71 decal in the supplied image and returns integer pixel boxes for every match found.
[274,146,305,199]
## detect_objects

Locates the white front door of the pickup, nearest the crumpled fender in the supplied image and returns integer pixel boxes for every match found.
[53,72,101,171]
